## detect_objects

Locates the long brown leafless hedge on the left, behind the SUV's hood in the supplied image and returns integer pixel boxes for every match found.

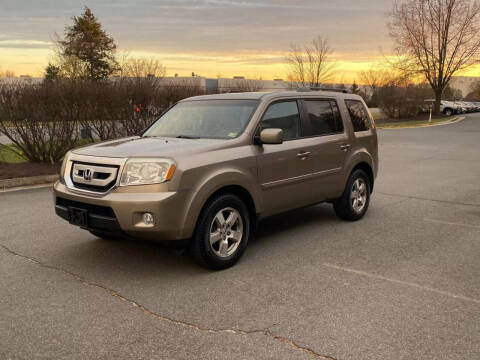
[0,77,203,163]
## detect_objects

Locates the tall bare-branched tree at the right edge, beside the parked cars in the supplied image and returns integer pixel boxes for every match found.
[389,0,480,114]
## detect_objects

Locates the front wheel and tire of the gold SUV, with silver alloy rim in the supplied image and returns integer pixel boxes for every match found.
[190,194,250,270]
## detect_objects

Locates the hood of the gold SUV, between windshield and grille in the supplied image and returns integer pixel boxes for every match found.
[73,136,229,158]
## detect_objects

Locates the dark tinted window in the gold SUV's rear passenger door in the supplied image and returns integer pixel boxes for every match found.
[304,100,343,136]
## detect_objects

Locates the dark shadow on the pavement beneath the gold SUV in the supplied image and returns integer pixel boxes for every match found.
[58,204,337,279]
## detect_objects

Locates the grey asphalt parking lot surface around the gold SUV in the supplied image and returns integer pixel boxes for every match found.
[0,114,480,360]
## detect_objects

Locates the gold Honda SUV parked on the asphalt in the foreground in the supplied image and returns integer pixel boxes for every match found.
[54,90,378,269]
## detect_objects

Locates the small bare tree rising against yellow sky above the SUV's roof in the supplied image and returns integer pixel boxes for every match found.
[286,36,336,87]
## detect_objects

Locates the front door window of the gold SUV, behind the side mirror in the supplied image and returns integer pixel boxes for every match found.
[260,101,300,140]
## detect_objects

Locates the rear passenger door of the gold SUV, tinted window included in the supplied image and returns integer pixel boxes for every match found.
[301,98,351,200]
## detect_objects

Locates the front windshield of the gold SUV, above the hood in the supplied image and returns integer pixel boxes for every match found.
[143,100,258,139]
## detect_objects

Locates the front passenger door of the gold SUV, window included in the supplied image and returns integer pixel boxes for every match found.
[256,100,320,215]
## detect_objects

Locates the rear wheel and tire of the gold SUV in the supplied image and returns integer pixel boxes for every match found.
[333,169,371,221]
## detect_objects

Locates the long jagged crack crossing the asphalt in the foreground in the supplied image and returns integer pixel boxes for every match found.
[0,244,337,360]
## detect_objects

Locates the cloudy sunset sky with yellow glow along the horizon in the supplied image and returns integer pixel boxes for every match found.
[0,0,480,83]
